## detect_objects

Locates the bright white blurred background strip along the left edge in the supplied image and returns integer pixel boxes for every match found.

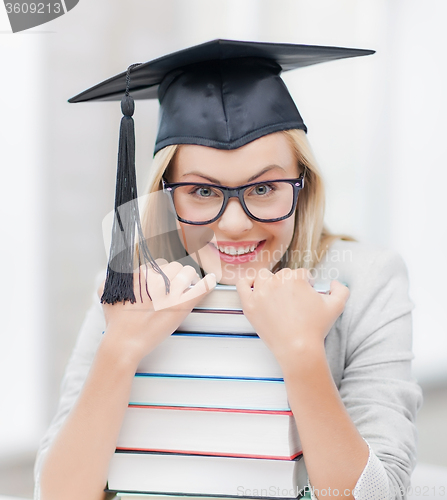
[0,8,46,460]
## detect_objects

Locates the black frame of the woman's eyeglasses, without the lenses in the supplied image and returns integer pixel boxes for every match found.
[162,174,304,226]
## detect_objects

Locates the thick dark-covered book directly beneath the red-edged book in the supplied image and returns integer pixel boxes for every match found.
[108,453,307,500]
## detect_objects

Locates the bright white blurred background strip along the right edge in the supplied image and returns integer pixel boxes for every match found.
[388,0,447,382]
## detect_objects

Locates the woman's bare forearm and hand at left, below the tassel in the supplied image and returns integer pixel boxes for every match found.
[41,260,216,500]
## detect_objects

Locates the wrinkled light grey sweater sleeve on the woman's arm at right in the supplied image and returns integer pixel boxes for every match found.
[339,251,422,500]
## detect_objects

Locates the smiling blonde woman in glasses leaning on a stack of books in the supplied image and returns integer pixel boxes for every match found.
[36,40,420,500]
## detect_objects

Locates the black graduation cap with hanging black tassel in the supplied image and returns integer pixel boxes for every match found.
[69,40,374,304]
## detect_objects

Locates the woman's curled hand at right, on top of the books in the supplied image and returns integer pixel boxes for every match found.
[236,269,349,364]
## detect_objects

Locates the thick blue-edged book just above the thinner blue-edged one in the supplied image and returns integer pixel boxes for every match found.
[137,333,283,379]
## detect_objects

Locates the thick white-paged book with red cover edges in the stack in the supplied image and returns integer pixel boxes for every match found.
[116,406,302,460]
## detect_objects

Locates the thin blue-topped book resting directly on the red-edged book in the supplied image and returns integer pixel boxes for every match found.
[129,373,290,411]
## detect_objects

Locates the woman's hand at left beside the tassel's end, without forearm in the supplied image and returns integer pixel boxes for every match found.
[98,259,216,364]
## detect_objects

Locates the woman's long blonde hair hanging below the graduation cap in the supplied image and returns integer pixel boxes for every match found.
[142,129,353,271]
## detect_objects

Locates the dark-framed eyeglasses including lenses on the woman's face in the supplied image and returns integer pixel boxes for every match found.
[162,174,304,225]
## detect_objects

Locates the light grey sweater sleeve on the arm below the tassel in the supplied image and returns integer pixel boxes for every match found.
[34,284,105,500]
